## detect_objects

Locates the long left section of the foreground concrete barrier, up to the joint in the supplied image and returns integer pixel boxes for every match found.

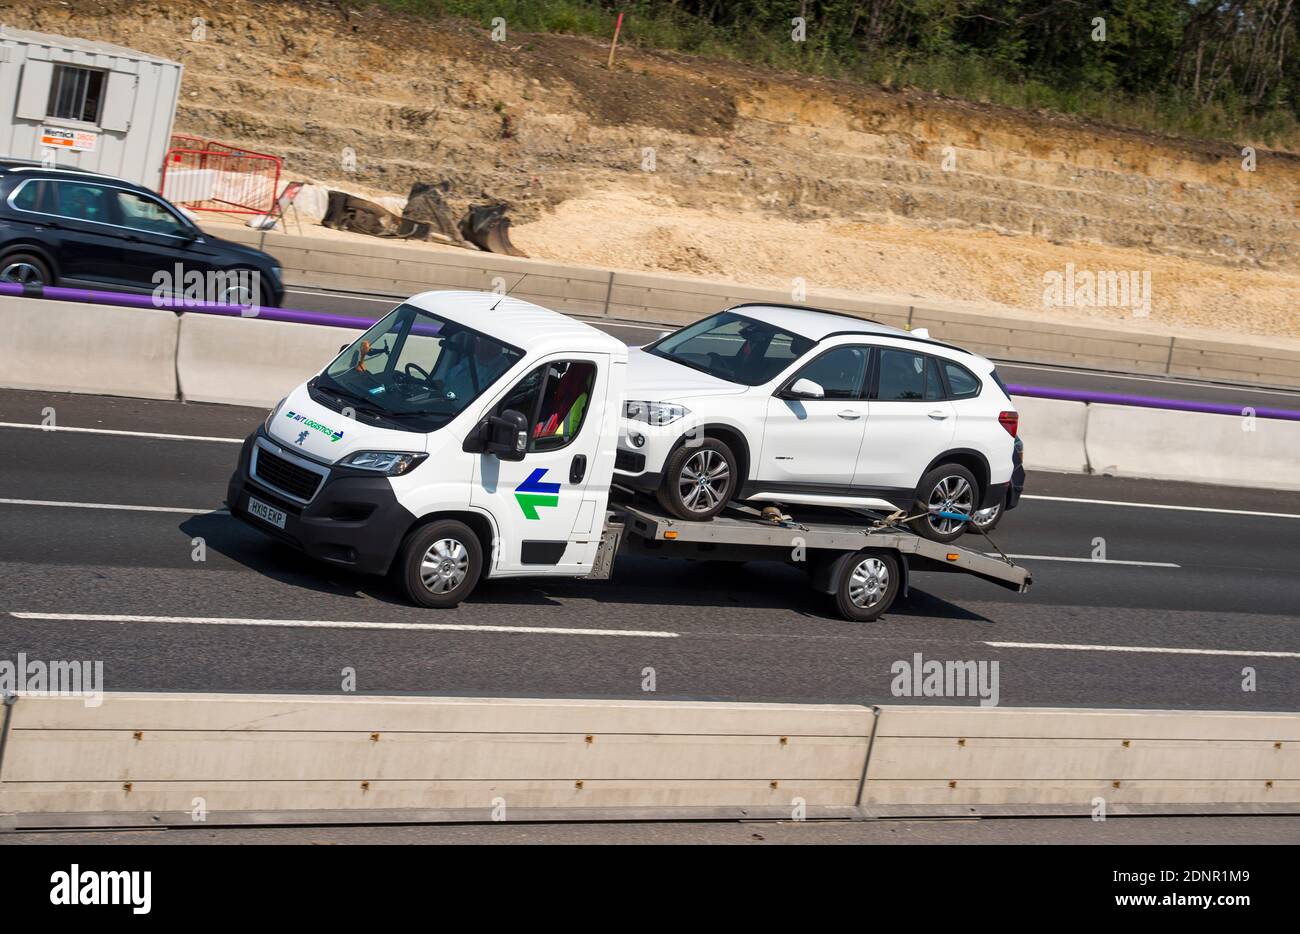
[0,695,870,826]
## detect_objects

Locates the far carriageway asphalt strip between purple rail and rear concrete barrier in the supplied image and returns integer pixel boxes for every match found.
[285,282,1300,410]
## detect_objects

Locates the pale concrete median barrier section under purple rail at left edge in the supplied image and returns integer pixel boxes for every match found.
[0,298,178,399]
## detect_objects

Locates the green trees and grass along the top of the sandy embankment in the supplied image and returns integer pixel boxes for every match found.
[369,0,1300,148]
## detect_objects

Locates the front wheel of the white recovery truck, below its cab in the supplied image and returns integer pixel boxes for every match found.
[393,519,484,609]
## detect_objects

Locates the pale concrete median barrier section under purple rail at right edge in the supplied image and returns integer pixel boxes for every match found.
[1081,405,1300,489]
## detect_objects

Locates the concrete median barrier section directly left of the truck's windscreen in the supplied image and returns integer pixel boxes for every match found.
[179,312,358,407]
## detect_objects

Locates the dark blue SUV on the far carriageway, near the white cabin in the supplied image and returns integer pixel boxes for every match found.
[0,160,285,307]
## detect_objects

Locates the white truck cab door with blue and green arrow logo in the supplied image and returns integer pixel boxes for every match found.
[469,354,610,576]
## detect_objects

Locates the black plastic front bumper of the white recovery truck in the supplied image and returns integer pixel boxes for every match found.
[226,428,415,574]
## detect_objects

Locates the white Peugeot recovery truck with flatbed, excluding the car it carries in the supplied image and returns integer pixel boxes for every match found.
[226,291,1030,620]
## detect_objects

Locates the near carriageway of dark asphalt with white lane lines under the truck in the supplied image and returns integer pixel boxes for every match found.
[0,392,1300,710]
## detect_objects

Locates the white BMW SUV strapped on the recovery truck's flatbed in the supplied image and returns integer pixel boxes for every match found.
[615,304,1019,541]
